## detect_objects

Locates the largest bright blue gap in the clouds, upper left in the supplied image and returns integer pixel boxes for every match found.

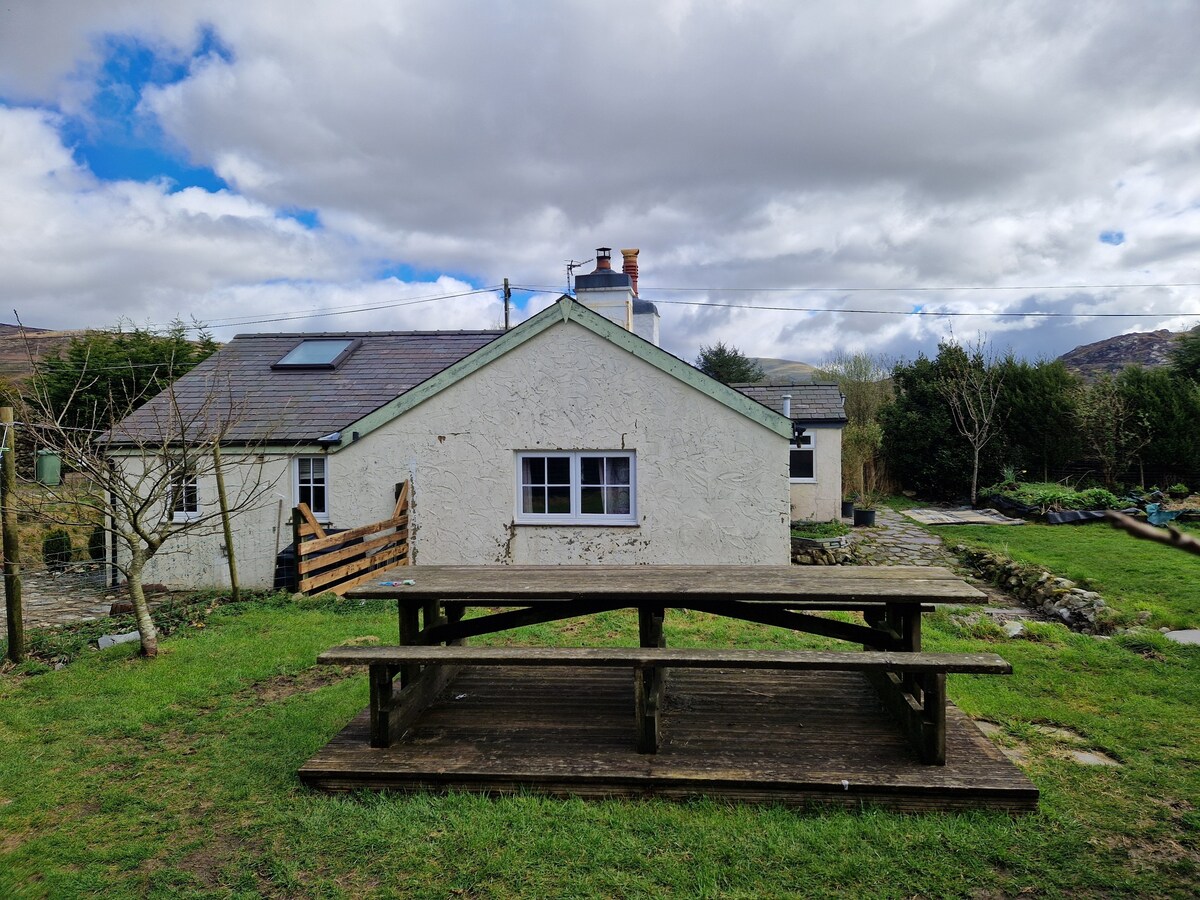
[61,28,233,191]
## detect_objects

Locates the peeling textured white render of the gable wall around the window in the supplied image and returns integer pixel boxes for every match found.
[330,322,788,565]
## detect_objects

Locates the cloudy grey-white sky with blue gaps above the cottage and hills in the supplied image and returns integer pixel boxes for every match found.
[0,0,1200,362]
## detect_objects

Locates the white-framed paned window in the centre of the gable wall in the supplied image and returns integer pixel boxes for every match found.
[515,450,637,524]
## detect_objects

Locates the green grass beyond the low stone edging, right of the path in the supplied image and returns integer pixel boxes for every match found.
[930,522,1200,629]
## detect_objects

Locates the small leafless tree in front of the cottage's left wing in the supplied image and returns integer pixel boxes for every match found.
[17,340,278,656]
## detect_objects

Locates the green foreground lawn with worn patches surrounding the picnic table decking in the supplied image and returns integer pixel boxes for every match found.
[0,595,1200,898]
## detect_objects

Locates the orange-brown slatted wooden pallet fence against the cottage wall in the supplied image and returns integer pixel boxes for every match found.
[292,481,409,594]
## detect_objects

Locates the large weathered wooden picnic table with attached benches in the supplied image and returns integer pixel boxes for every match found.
[336,565,993,763]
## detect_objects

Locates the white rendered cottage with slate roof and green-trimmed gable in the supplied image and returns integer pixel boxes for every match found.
[110,278,792,588]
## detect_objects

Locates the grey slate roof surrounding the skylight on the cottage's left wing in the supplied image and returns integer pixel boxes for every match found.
[110,331,504,445]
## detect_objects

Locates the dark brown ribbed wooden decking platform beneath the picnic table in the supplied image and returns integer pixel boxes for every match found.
[299,667,1038,814]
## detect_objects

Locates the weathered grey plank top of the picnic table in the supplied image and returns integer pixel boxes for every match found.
[347,565,988,606]
